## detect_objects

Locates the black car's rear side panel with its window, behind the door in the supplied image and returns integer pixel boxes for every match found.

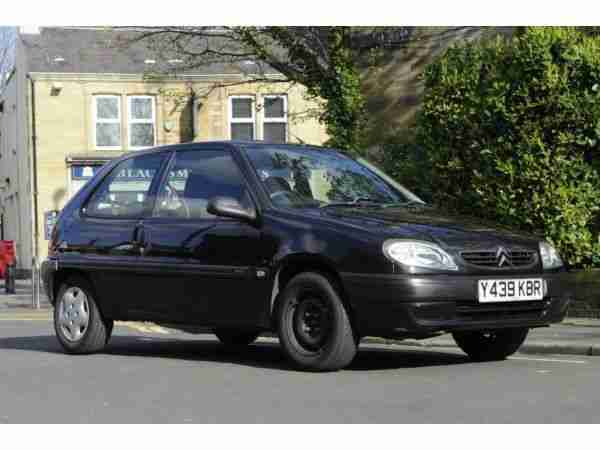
[74,152,166,318]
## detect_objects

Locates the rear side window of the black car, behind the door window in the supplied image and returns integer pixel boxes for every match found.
[85,154,165,218]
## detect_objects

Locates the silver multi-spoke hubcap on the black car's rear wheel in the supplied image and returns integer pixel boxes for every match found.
[58,287,90,342]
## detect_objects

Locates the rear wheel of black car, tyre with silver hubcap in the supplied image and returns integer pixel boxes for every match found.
[54,277,113,354]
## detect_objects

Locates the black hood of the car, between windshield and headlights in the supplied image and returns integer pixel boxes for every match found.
[307,205,540,249]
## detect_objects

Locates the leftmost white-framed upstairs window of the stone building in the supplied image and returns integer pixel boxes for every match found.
[94,95,121,150]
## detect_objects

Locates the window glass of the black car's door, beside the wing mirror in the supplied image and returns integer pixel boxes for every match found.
[153,150,252,219]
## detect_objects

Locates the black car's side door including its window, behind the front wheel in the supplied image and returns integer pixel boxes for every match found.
[135,147,268,326]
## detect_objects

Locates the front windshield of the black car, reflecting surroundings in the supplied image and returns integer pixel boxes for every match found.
[246,145,423,207]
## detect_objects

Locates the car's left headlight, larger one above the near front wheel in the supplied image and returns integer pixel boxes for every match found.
[383,240,458,270]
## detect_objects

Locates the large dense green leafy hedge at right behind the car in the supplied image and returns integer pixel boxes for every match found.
[414,27,600,266]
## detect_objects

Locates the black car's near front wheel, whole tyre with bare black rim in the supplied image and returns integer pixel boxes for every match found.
[276,272,358,371]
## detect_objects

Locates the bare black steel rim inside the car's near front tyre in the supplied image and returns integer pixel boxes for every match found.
[294,297,332,351]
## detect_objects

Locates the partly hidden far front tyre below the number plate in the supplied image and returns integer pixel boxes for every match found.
[452,328,529,361]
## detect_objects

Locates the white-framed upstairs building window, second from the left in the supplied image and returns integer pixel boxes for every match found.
[128,95,156,150]
